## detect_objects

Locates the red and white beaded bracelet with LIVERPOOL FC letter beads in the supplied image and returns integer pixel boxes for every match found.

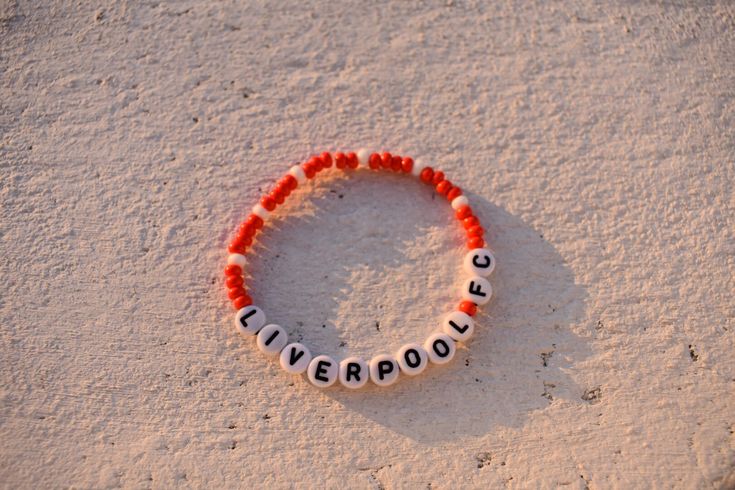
[225,149,495,389]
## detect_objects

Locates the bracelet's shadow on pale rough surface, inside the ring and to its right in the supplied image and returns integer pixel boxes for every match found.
[247,170,591,444]
